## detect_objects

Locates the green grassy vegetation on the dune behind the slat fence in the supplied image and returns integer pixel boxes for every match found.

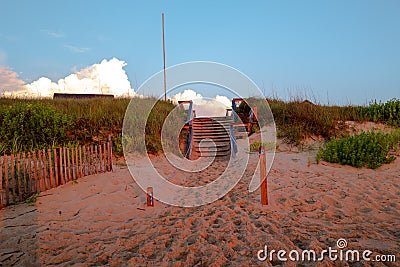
[0,98,175,155]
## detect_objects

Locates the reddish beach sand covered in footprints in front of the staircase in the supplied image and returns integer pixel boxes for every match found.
[0,137,400,266]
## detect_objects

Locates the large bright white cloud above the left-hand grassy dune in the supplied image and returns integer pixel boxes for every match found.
[5,58,136,97]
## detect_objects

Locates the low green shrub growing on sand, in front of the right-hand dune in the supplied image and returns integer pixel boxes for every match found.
[317,130,400,169]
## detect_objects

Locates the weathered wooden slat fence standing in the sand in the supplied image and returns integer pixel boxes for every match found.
[0,137,112,208]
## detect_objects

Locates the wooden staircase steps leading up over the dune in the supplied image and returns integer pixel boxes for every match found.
[190,117,233,160]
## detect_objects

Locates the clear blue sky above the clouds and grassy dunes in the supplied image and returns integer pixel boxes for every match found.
[0,0,400,104]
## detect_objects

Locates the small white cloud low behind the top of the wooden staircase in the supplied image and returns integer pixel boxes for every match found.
[171,89,231,117]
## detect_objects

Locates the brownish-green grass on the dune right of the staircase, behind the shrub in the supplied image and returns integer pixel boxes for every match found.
[237,98,400,145]
